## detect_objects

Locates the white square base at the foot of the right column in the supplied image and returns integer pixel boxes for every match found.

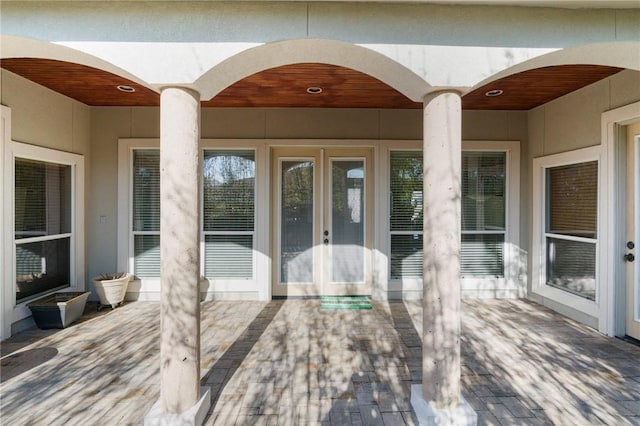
[411,385,478,426]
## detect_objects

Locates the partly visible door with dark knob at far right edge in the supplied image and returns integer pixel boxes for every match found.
[625,123,640,340]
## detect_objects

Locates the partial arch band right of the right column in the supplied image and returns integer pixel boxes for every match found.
[465,42,640,93]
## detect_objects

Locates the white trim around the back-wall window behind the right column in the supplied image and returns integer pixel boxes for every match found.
[374,140,527,297]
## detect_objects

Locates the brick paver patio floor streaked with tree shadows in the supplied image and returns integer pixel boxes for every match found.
[0,300,640,425]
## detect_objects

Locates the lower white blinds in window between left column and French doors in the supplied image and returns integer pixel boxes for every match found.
[204,235,253,279]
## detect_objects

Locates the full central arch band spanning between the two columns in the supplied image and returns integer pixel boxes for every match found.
[194,39,432,102]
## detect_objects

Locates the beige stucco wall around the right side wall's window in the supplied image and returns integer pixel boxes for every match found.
[522,70,640,327]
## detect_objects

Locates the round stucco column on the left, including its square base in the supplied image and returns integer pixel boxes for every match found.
[145,87,210,425]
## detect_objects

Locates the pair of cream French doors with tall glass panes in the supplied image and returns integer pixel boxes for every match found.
[272,148,373,296]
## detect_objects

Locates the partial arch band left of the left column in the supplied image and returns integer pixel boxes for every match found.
[0,35,159,92]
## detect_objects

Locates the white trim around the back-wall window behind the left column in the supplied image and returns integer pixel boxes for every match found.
[117,138,271,300]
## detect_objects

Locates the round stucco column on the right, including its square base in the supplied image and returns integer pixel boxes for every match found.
[411,91,477,425]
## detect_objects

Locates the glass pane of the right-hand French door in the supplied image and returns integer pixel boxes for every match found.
[329,160,365,283]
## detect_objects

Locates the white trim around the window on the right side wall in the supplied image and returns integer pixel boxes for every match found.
[531,146,607,318]
